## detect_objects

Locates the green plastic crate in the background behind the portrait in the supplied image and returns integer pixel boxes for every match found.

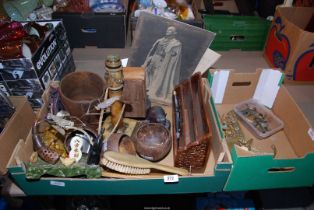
[204,15,271,51]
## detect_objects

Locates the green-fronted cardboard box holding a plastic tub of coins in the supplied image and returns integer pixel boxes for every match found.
[209,71,314,191]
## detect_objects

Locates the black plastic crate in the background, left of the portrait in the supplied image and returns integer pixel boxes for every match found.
[52,12,127,48]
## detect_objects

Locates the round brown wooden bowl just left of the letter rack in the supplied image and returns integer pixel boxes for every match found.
[135,123,171,161]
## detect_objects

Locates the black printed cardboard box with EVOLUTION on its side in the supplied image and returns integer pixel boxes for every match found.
[0,21,75,108]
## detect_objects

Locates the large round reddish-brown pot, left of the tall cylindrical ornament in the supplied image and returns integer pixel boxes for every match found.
[60,72,106,128]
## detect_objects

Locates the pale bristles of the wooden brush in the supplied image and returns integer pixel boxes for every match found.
[101,157,150,175]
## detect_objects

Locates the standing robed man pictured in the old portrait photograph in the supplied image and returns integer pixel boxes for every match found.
[143,26,182,103]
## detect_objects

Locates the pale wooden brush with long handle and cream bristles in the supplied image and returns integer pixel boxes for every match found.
[100,151,189,176]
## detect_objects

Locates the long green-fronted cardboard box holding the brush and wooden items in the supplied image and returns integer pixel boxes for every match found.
[8,79,232,195]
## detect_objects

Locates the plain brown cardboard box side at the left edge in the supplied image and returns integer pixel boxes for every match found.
[0,96,35,175]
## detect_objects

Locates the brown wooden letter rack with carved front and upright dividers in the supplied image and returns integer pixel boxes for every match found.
[172,73,212,172]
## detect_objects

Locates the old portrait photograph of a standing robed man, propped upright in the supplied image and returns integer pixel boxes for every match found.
[128,12,215,103]
